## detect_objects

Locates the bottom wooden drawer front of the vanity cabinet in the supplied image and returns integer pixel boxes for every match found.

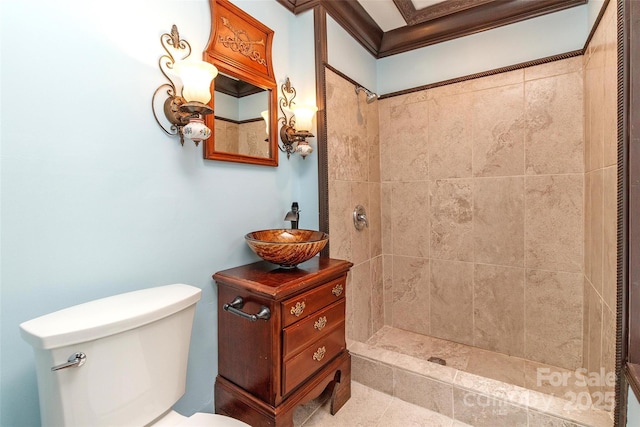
[282,322,346,395]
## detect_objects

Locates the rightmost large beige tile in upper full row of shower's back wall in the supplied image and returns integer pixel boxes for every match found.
[525,71,584,175]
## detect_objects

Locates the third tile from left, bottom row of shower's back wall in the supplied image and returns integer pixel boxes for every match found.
[473,264,524,357]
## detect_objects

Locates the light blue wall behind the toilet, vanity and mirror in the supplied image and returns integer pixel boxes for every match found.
[0,0,318,427]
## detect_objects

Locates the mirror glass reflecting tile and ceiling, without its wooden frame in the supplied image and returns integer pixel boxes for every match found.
[214,74,271,157]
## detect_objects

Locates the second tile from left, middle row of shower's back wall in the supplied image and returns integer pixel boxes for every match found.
[430,179,474,261]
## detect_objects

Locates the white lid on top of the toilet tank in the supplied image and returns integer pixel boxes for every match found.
[20,284,202,349]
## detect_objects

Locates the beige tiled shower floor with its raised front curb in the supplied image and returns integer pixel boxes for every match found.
[348,326,613,427]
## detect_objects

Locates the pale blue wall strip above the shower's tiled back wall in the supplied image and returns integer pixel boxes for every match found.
[377,5,590,94]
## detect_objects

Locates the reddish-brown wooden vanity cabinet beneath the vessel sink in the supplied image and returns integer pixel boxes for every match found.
[213,257,352,427]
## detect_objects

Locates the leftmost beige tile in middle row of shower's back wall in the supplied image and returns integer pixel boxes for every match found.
[391,182,429,258]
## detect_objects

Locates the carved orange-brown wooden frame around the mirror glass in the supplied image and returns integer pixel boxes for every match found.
[203,0,278,166]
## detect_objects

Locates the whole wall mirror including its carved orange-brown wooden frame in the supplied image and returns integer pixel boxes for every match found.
[204,0,278,166]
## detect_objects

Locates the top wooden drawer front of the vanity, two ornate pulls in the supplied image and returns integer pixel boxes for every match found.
[281,277,346,327]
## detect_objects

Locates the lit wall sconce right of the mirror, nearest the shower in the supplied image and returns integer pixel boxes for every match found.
[278,77,318,159]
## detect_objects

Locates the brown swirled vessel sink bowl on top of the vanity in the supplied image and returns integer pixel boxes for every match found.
[244,229,329,268]
